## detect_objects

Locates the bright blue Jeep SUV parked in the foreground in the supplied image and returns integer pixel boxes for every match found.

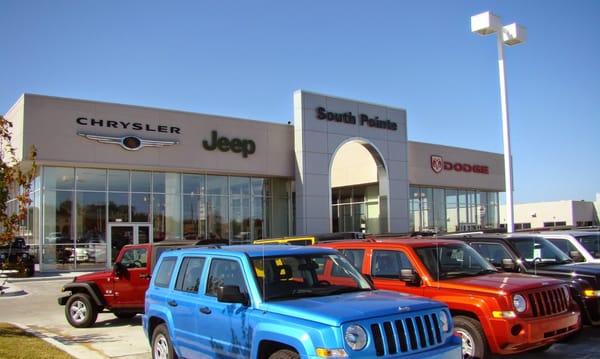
[143,245,461,359]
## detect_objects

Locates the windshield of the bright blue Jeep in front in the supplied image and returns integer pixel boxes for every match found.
[252,254,373,301]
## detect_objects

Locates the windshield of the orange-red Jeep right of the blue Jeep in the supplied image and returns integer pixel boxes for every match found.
[415,243,497,280]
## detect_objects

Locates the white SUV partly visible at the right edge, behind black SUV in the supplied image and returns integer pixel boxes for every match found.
[540,231,600,263]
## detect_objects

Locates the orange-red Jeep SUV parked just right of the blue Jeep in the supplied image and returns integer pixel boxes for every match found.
[319,238,581,358]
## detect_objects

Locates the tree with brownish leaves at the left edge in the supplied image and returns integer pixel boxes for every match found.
[0,116,37,244]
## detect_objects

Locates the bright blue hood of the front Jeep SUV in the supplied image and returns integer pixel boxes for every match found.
[261,290,445,326]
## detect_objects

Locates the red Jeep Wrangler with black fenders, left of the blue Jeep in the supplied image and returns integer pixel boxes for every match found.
[58,241,202,328]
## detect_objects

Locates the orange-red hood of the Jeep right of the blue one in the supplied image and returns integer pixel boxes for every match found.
[433,272,563,295]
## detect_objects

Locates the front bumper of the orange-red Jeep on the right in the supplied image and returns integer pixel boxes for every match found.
[492,311,581,354]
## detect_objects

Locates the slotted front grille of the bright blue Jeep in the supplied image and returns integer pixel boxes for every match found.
[371,313,442,356]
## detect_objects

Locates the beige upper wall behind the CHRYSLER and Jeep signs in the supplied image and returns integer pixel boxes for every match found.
[18,95,294,178]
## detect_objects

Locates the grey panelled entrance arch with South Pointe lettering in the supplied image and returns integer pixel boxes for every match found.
[294,90,409,235]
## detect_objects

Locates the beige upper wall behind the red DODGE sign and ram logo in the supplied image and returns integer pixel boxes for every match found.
[408,141,504,192]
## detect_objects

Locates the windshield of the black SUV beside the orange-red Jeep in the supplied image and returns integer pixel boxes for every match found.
[511,237,573,267]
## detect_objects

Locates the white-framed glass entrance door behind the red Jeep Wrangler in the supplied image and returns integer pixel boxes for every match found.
[107,223,152,266]
